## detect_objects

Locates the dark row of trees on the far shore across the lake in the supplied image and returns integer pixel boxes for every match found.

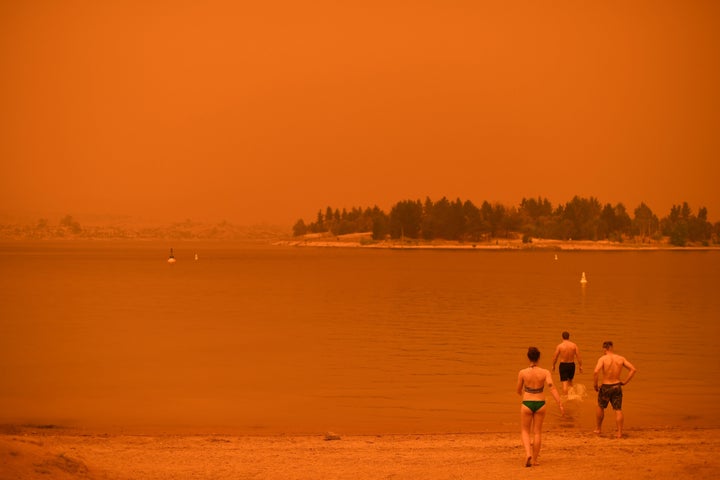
[293,196,720,246]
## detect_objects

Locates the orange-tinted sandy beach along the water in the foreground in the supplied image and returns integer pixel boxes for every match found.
[0,426,720,480]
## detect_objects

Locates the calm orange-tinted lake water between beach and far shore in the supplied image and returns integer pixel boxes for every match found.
[0,242,720,434]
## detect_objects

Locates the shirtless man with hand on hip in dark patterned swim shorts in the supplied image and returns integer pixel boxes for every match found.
[593,341,637,438]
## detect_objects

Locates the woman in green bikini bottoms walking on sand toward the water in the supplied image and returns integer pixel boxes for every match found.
[517,347,565,467]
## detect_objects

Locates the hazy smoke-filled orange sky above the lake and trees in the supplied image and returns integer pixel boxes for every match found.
[0,0,720,225]
